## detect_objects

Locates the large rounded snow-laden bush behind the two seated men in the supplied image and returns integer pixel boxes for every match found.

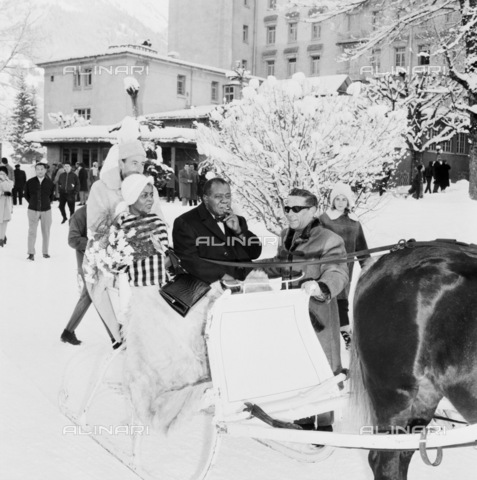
[197,74,406,233]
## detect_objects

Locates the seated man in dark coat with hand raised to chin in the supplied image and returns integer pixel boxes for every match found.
[172,178,262,283]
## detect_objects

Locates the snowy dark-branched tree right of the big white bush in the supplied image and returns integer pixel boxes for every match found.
[365,72,469,165]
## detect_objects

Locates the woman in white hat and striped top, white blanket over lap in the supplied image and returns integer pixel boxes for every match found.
[118,174,221,431]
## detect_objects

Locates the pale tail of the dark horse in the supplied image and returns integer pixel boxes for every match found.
[346,330,376,432]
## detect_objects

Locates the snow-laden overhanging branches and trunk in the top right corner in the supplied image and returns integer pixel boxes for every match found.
[285,0,477,200]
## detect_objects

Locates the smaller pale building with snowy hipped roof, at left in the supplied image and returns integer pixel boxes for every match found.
[38,45,237,129]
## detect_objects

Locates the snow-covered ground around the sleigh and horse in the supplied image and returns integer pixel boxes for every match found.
[0,181,477,480]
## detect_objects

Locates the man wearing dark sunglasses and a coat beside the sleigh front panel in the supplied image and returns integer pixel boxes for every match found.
[277,188,348,431]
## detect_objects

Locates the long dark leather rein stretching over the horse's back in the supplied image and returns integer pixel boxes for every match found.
[201,238,477,268]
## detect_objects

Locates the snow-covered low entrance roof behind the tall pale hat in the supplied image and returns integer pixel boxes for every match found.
[25,125,196,144]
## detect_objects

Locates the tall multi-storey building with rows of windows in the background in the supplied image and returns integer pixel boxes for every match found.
[168,0,458,80]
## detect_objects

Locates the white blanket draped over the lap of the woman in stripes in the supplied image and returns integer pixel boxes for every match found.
[123,282,222,431]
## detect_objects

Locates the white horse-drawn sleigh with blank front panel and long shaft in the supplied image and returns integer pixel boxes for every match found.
[60,256,477,480]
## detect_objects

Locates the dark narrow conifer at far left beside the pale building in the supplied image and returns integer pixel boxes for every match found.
[8,75,42,162]
